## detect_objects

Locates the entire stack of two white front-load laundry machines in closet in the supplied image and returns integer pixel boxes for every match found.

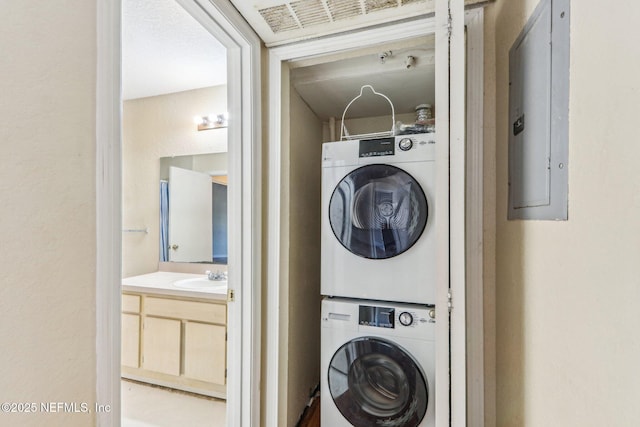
[321,133,436,427]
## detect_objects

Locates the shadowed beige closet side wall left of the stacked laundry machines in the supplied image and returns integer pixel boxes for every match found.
[287,88,322,426]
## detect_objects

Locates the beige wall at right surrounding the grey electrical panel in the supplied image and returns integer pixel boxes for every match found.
[485,0,640,427]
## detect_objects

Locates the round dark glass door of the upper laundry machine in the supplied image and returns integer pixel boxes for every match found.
[329,164,428,259]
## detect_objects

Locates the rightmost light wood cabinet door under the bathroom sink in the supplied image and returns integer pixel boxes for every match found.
[184,322,227,385]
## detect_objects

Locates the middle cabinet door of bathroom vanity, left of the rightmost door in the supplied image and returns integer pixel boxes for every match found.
[142,317,181,375]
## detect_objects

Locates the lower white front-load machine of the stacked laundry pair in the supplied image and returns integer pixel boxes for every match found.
[320,298,435,427]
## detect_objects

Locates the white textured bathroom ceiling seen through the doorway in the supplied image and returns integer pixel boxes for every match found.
[122,0,227,99]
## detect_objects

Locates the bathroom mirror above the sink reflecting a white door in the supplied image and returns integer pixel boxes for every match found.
[160,153,227,264]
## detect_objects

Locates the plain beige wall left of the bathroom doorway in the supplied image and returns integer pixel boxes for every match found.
[0,0,97,427]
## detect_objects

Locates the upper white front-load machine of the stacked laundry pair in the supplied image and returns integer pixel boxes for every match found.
[321,133,436,304]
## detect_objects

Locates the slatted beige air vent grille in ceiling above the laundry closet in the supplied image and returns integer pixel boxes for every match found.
[258,0,427,34]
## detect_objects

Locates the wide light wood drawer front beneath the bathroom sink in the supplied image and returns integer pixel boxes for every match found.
[144,297,227,325]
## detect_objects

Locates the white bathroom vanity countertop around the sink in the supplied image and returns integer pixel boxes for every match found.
[122,271,227,300]
